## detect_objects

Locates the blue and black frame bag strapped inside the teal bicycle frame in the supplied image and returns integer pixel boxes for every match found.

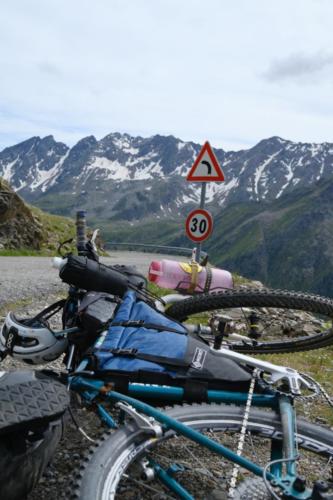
[93,291,251,400]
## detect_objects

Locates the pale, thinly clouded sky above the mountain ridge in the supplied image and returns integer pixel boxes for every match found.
[0,0,333,150]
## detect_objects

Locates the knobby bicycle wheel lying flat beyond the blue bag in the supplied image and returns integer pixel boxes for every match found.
[167,288,333,354]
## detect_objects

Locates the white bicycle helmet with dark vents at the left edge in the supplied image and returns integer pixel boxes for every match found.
[0,312,67,365]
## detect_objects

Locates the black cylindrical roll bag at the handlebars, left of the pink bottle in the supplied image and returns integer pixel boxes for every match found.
[59,255,129,297]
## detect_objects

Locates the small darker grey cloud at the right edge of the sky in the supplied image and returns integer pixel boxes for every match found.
[263,52,333,82]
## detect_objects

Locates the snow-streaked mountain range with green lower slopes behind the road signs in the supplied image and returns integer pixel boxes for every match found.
[0,133,333,295]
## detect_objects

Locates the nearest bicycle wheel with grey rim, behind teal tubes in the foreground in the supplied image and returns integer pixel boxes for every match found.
[71,404,333,500]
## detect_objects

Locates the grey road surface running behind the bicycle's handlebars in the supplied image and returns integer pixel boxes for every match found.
[0,251,185,307]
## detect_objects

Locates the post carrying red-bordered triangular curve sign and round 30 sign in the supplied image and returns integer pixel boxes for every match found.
[186,141,224,263]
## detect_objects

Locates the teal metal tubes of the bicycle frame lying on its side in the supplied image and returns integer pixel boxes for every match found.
[70,361,311,500]
